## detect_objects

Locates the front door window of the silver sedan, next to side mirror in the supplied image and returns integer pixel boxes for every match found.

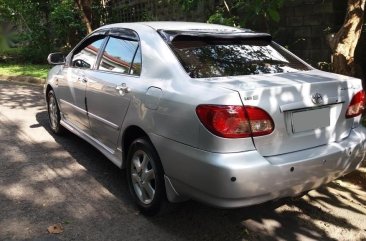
[72,36,104,69]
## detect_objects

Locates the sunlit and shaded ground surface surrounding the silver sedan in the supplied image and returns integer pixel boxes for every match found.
[0,82,366,241]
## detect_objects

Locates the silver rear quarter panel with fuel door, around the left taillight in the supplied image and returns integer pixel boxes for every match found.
[110,23,254,152]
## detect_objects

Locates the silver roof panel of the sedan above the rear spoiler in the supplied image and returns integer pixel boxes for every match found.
[98,21,246,32]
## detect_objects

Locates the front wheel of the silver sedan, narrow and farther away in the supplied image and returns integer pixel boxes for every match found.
[47,90,65,135]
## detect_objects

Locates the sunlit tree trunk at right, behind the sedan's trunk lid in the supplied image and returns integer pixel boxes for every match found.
[329,0,366,76]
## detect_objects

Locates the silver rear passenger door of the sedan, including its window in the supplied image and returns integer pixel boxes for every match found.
[86,30,141,150]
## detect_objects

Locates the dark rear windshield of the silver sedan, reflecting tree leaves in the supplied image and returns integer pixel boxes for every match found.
[170,38,309,78]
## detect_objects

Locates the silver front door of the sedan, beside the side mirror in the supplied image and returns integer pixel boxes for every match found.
[58,35,105,132]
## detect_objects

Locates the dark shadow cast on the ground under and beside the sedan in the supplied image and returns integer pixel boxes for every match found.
[32,108,365,240]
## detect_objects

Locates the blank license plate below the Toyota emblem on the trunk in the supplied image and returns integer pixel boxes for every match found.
[292,108,330,133]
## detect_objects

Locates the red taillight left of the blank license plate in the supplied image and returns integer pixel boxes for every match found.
[196,105,274,138]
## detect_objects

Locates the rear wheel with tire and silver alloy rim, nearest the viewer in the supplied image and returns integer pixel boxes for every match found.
[126,138,166,216]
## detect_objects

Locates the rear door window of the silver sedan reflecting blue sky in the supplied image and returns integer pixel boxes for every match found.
[99,37,138,74]
